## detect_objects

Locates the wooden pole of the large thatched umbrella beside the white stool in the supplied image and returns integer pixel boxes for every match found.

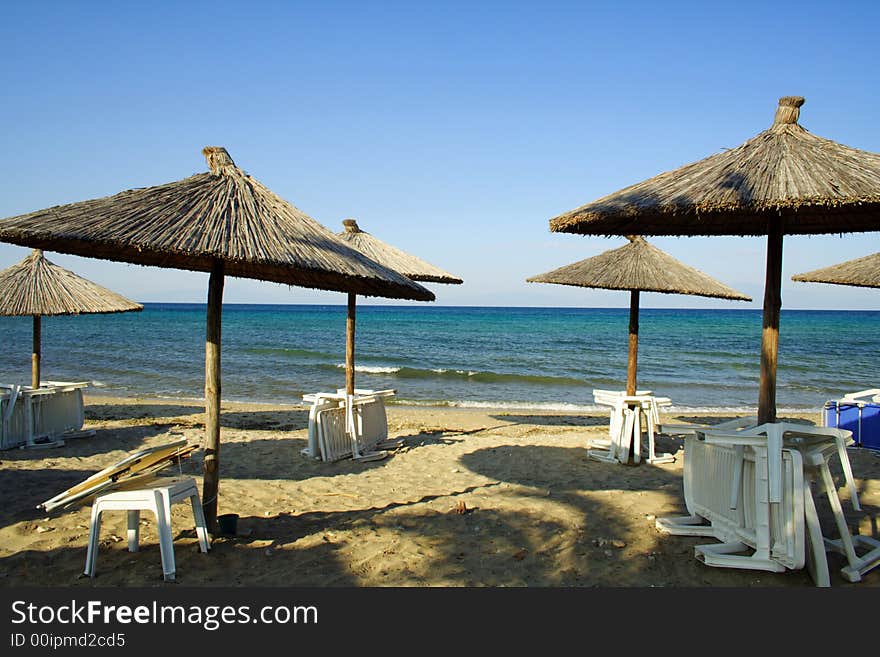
[202,260,224,533]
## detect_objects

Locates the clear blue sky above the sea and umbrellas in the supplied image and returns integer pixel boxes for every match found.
[0,0,880,309]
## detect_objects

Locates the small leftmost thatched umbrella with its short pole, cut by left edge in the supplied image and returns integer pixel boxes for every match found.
[0,249,144,390]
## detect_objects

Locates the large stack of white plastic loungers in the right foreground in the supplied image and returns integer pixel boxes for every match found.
[656,418,880,586]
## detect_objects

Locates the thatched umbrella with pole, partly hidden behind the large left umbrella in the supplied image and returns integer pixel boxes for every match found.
[337,219,464,395]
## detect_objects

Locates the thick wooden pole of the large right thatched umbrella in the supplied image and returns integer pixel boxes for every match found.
[758,217,782,424]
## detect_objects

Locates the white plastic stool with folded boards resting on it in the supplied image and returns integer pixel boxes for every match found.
[85,477,210,581]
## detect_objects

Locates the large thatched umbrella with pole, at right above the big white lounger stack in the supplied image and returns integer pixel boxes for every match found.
[550,96,880,423]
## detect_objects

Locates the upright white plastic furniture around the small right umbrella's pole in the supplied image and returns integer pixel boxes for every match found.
[587,389,675,464]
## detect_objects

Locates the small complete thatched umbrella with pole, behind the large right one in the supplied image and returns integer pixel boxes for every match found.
[526,235,751,395]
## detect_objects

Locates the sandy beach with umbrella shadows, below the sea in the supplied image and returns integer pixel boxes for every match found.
[0,396,880,588]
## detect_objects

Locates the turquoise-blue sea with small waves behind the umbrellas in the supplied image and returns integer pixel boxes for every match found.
[0,303,880,411]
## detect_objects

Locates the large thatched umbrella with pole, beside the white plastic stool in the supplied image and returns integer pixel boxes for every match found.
[0,146,434,530]
